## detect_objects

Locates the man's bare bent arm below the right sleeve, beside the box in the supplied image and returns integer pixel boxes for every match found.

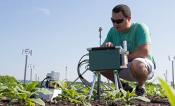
[128,44,150,61]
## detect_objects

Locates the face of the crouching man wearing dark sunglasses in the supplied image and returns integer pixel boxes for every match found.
[111,12,130,32]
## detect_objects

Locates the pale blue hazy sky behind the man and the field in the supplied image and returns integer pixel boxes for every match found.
[0,0,175,81]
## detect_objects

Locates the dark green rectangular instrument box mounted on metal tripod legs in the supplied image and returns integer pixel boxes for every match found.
[88,46,121,71]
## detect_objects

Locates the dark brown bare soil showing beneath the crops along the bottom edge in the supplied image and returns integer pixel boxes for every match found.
[0,96,170,106]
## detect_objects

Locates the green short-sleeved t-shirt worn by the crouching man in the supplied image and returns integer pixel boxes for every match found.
[103,23,153,61]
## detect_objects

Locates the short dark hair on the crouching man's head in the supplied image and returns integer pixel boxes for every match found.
[112,4,131,17]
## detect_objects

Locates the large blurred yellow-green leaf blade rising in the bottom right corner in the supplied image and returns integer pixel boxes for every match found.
[159,79,175,106]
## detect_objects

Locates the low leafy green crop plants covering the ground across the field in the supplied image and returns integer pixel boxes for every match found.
[0,76,175,106]
